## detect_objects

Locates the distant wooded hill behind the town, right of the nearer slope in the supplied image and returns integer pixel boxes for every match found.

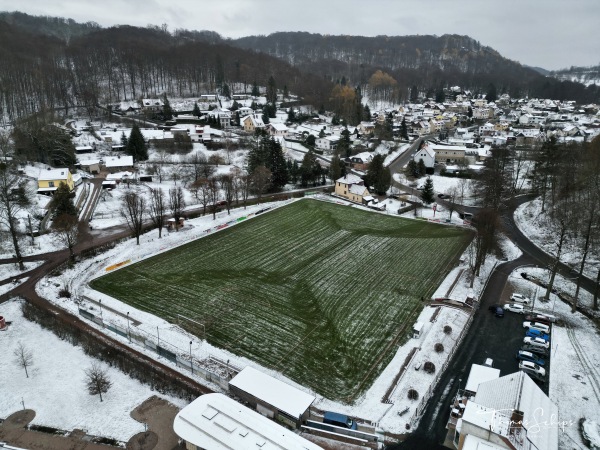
[232,32,600,102]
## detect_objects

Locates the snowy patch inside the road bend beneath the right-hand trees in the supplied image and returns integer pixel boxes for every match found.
[514,198,600,279]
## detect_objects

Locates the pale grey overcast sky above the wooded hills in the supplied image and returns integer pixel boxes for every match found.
[0,0,600,70]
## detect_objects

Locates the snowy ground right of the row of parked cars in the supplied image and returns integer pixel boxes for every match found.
[509,267,600,449]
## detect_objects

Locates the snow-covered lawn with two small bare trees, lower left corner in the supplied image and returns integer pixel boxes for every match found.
[0,300,184,441]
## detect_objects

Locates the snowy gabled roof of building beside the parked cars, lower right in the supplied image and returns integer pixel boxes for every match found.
[475,372,558,450]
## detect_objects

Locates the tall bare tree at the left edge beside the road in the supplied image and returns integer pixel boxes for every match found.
[0,161,30,270]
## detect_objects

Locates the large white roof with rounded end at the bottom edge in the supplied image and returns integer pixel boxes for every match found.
[173,394,321,450]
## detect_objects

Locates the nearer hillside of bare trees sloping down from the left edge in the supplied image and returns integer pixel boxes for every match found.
[0,18,332,119]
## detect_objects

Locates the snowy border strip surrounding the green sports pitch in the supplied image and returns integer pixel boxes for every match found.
[30,199,508,433]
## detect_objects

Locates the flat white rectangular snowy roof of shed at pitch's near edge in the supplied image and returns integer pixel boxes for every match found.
[229,366,315,418]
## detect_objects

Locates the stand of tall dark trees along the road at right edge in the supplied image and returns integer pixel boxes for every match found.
[473,138,600,309]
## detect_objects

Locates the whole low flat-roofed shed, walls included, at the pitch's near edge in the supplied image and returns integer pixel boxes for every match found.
[229,367,315,428]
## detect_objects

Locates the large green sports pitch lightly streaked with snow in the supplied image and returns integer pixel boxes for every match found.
[91,200,470,402]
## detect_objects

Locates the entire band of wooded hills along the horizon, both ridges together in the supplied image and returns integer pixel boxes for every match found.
[0,13,600,123]
